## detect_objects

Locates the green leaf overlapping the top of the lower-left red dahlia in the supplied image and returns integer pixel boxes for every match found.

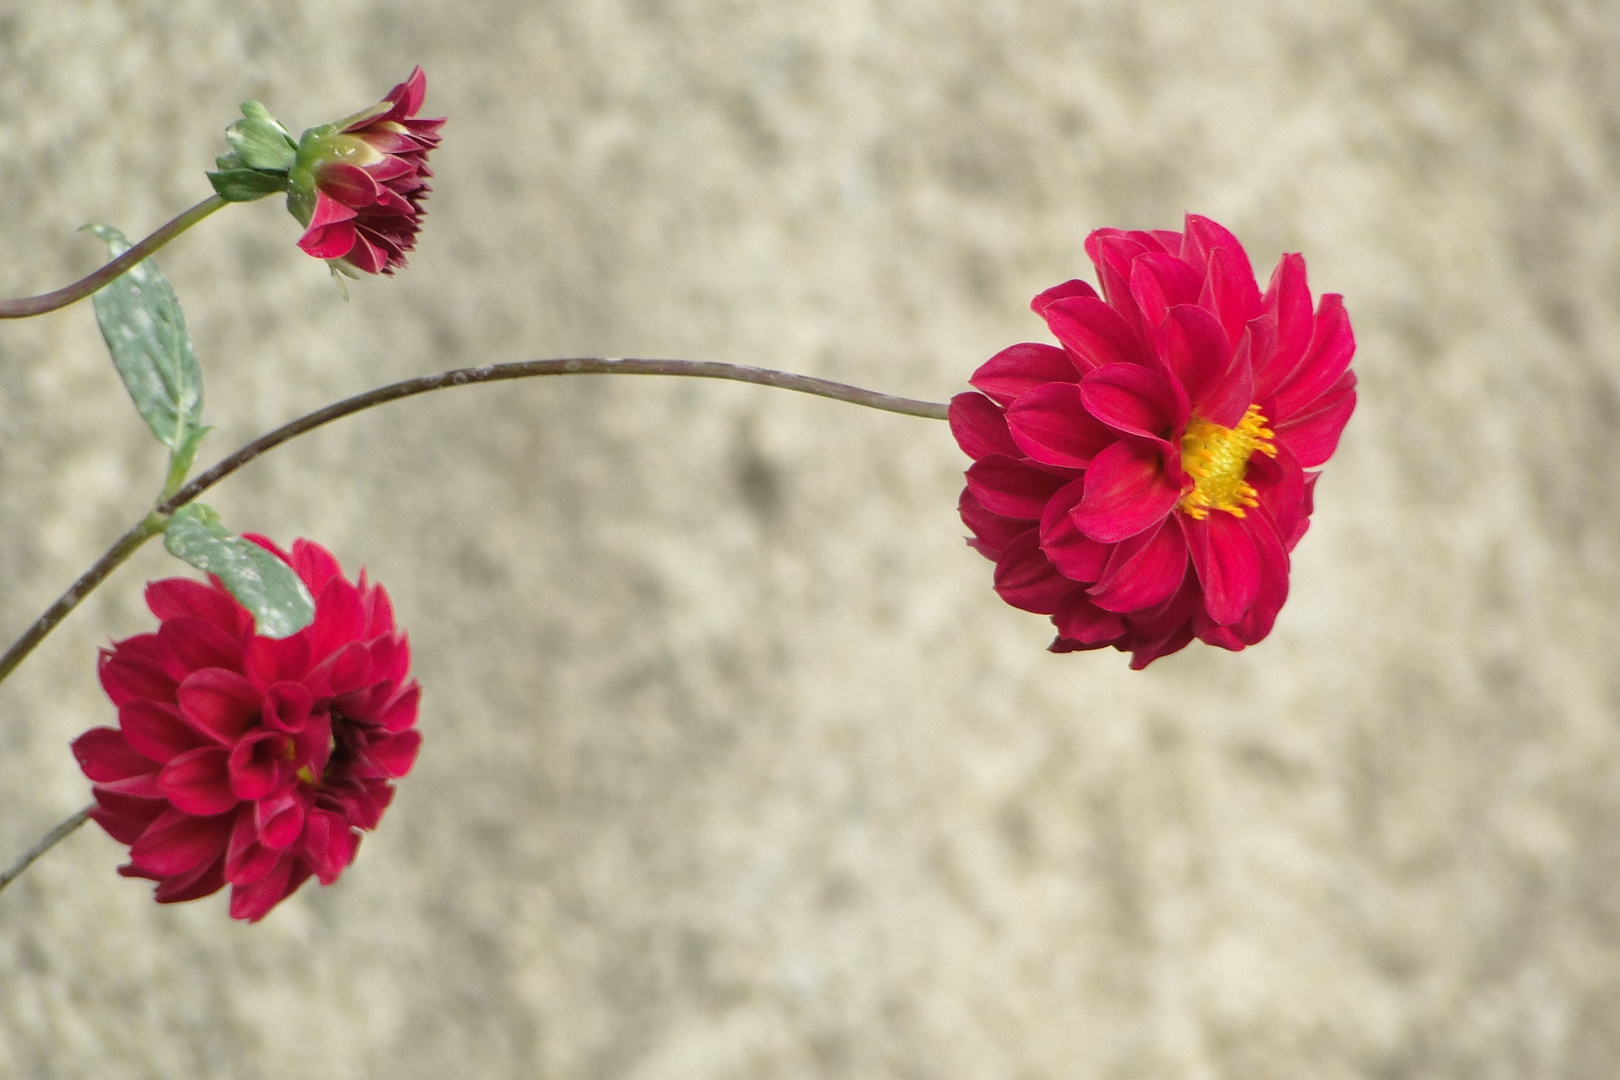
[164,502,314,638]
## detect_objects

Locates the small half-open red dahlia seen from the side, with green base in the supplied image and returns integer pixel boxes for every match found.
[287,68,444,274]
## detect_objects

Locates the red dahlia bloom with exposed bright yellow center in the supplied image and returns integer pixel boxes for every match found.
[951,214,1356,669]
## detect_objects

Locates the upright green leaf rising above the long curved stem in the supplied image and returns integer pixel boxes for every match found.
[86,225,203,457]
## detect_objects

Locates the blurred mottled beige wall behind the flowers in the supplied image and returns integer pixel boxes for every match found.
[0,0,1620,1080]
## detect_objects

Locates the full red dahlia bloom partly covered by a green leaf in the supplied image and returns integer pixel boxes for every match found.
[73,536,421,921]
